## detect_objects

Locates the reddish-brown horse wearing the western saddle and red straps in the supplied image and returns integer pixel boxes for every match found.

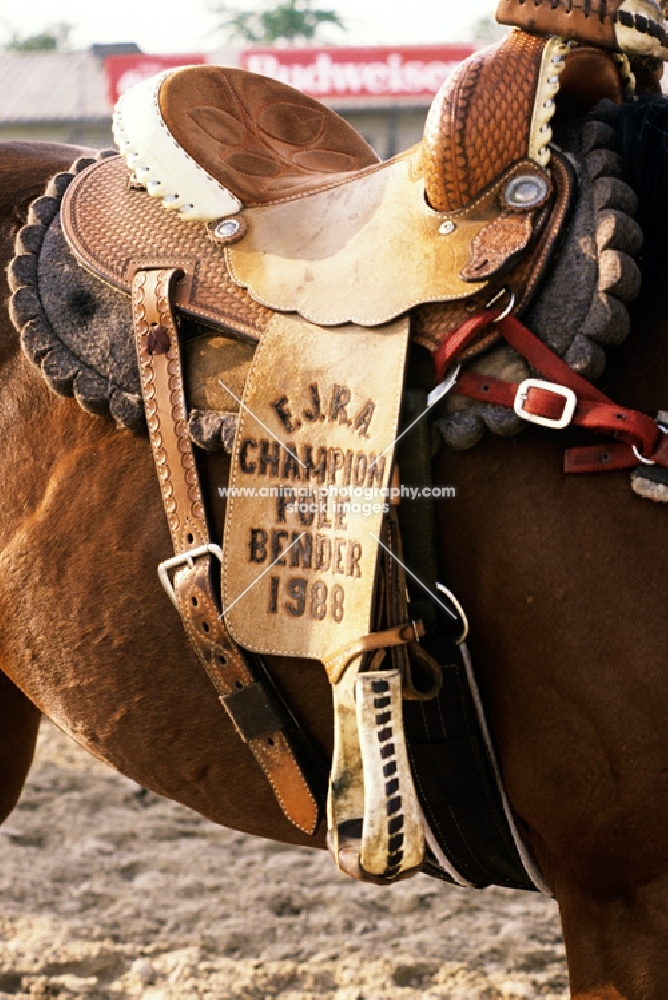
[0,90,668,1000]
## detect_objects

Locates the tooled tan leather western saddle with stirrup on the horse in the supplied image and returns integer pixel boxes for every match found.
[57,0,665,881]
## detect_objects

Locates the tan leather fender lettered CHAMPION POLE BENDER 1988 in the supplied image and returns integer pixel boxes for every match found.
[222,315,408,660]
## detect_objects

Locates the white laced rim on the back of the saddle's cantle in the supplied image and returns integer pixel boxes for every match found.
[113,69,243,222]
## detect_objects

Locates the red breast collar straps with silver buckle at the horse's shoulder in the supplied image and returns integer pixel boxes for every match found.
[434,310,668,472]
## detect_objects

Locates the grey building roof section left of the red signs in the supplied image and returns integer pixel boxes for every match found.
[0,52,112,123]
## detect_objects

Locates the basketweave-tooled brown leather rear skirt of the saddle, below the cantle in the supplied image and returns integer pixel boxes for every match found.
[61,156,271,340]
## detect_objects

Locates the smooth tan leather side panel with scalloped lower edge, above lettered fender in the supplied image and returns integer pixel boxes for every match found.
[225,146,549,326]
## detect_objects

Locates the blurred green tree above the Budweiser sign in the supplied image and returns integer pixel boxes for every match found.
[217,0,346,45]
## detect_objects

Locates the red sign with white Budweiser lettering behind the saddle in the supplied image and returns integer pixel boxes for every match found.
[241,45,473,99]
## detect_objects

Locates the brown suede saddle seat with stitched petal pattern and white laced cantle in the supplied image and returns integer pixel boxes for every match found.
[114,66,379,218]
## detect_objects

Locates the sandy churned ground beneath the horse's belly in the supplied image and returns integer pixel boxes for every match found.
[0,723,568,1000]
